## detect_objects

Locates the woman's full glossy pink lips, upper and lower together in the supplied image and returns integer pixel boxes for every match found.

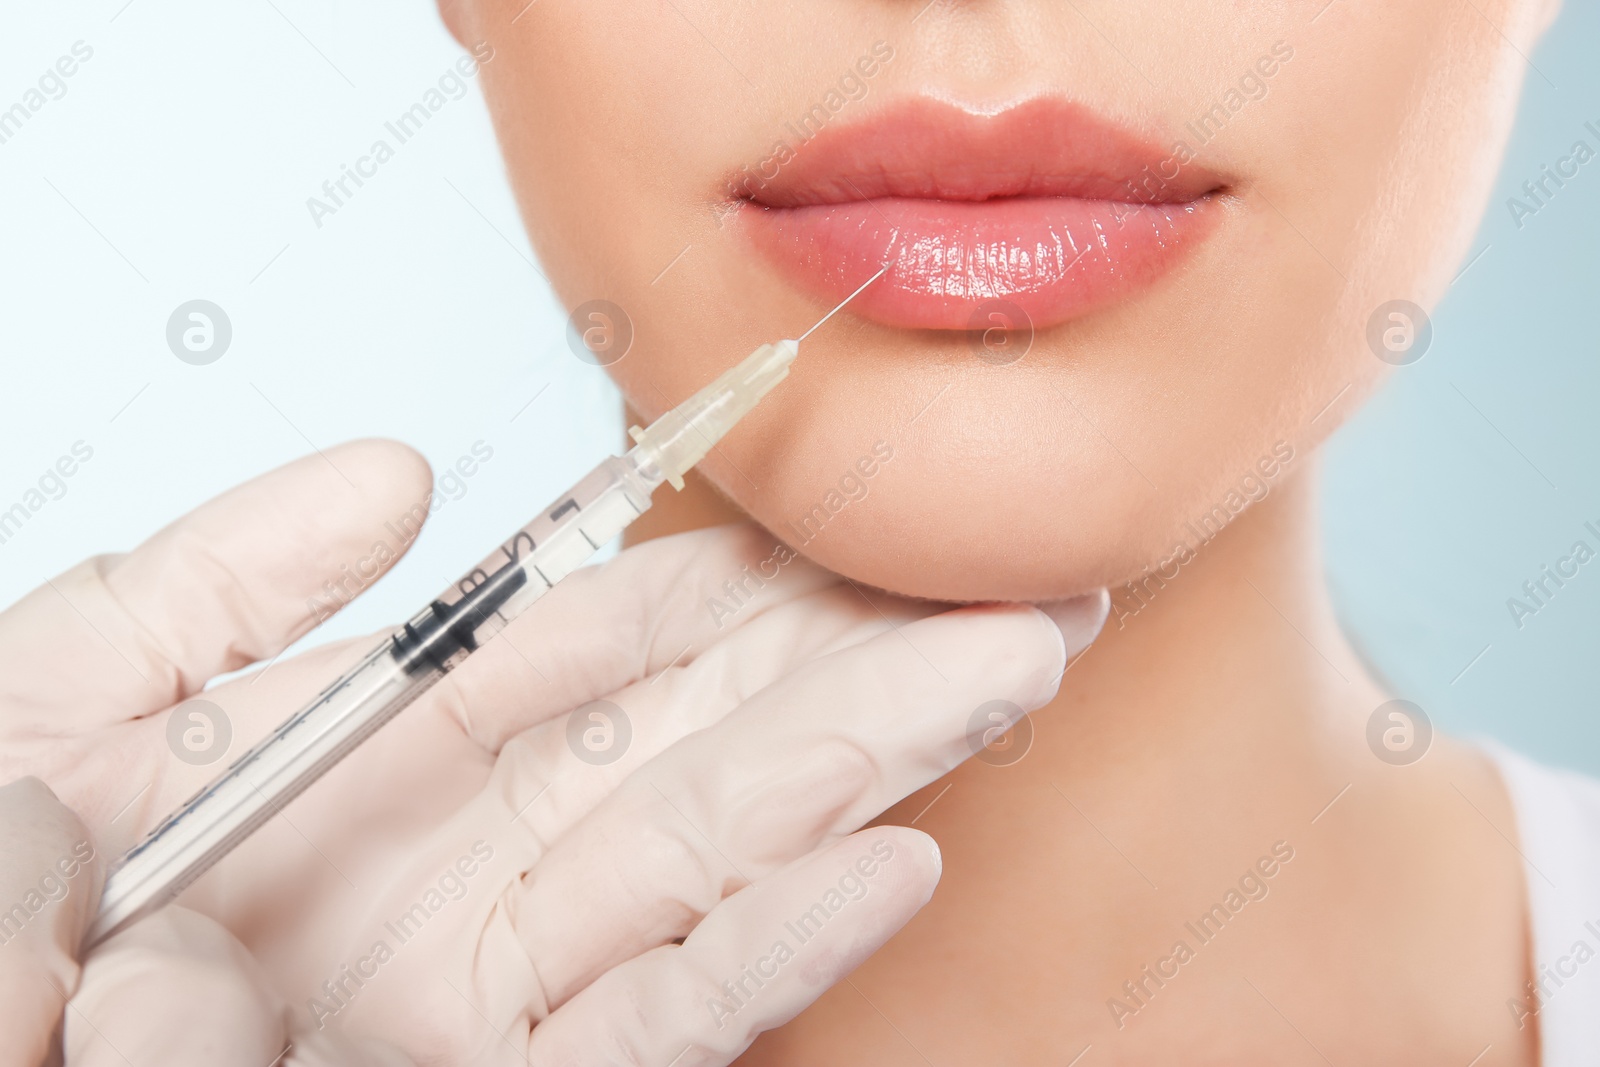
[728,98,1226,330]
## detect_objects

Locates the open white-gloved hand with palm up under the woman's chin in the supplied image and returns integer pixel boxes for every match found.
[0,442,1107,1067]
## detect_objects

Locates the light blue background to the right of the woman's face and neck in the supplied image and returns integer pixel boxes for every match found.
[1323,2,1600,774]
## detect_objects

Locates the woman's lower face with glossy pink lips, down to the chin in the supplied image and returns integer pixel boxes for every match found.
[445,0,1550,600]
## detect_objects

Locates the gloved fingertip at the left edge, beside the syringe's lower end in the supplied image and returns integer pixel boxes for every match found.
[0,777,104,1067]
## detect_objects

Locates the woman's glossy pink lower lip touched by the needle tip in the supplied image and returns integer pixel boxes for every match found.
[744,197,1216,330]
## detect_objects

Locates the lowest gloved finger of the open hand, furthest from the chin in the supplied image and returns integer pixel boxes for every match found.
[528,827,939,1067]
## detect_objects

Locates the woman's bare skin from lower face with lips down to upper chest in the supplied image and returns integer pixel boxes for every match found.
[428,0,1554,1064]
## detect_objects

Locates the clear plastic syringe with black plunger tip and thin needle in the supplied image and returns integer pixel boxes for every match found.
[86,335,812,945]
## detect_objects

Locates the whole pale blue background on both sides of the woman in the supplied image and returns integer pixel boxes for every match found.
[0,0,1600,773]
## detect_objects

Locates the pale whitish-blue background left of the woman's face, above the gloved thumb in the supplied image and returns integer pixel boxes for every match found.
[0,0,622,668]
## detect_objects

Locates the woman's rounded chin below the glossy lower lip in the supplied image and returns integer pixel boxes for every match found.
[702,368,1184,601]
